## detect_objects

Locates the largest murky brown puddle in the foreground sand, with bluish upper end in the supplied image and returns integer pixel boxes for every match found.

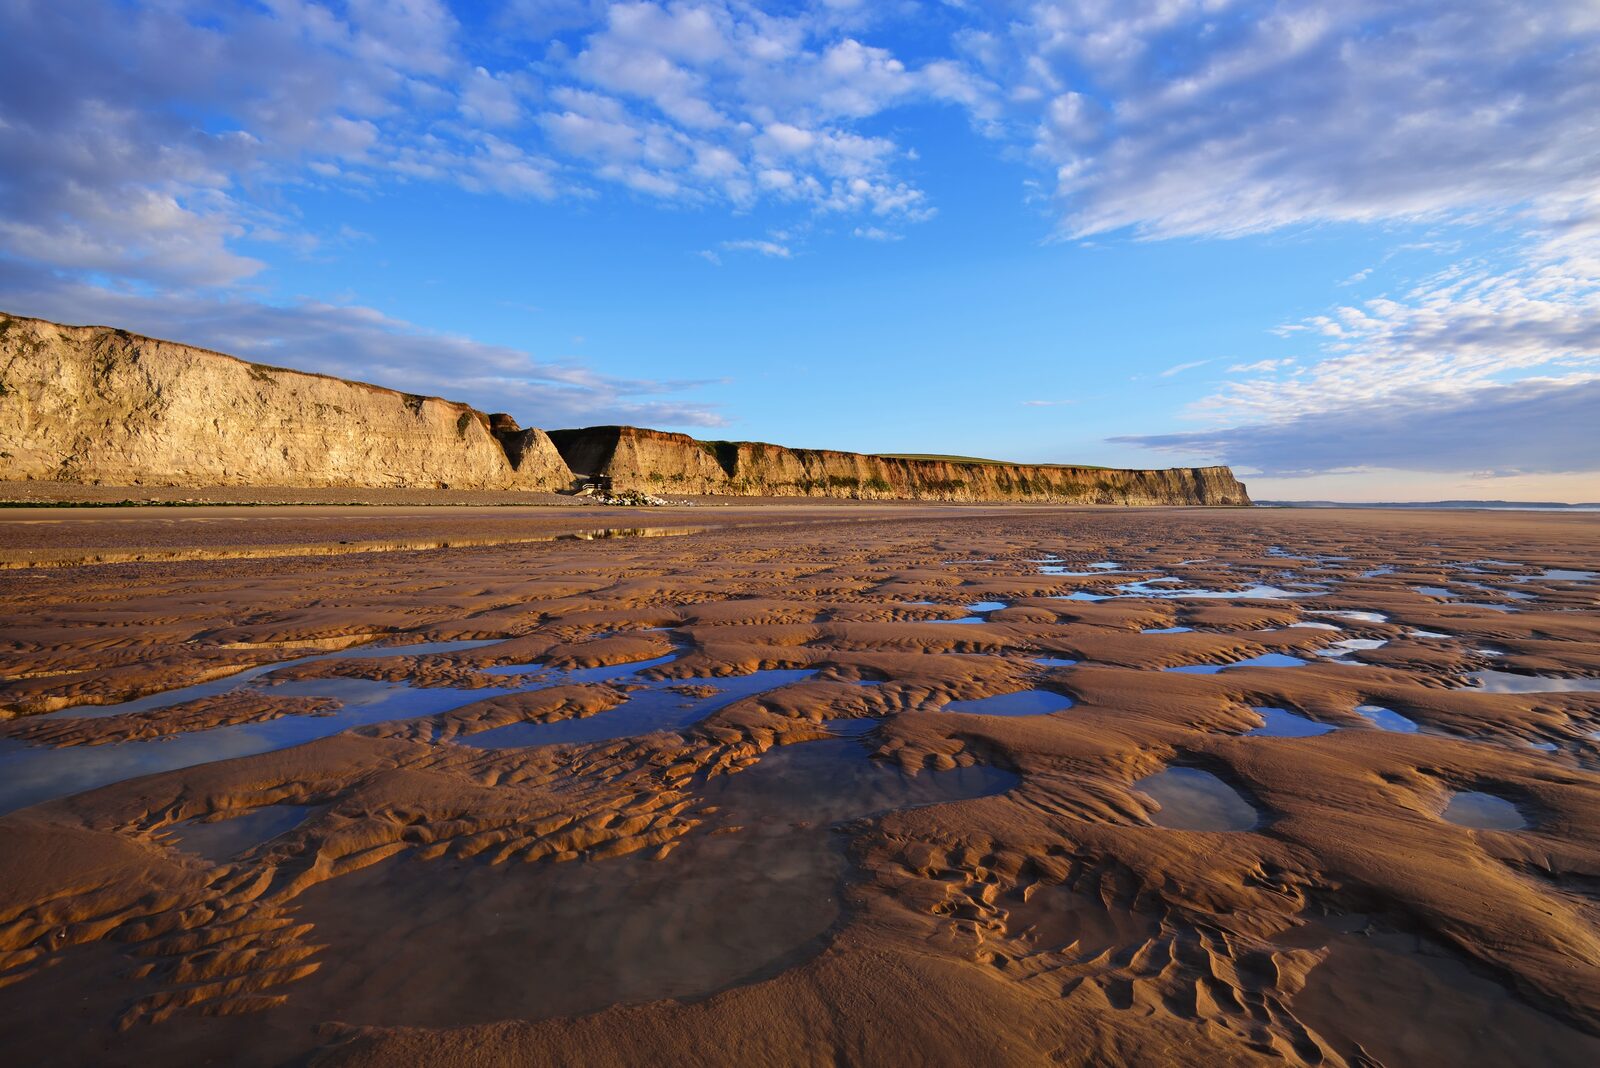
[288,739,1018,1026]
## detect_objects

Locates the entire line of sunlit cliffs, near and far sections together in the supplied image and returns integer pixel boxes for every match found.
[0,313,1250,505]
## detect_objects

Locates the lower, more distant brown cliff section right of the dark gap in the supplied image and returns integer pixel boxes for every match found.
[550,427,1250,505]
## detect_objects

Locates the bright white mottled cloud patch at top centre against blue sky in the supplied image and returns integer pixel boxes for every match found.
[538,2,960,221]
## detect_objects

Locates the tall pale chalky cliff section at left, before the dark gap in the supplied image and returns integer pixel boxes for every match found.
[0,315,571,489]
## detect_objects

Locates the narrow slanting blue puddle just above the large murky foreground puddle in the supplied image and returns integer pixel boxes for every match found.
[456,668,814,748]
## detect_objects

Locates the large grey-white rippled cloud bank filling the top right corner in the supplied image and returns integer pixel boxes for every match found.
[963,0,1600,237]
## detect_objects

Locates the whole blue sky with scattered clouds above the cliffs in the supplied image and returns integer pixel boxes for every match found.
[0,0,1600,502]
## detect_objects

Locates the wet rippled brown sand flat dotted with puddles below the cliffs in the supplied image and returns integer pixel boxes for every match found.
[0,505,1600,1065]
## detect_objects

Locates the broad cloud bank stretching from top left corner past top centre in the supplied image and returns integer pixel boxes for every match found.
[0,0,987,286]
